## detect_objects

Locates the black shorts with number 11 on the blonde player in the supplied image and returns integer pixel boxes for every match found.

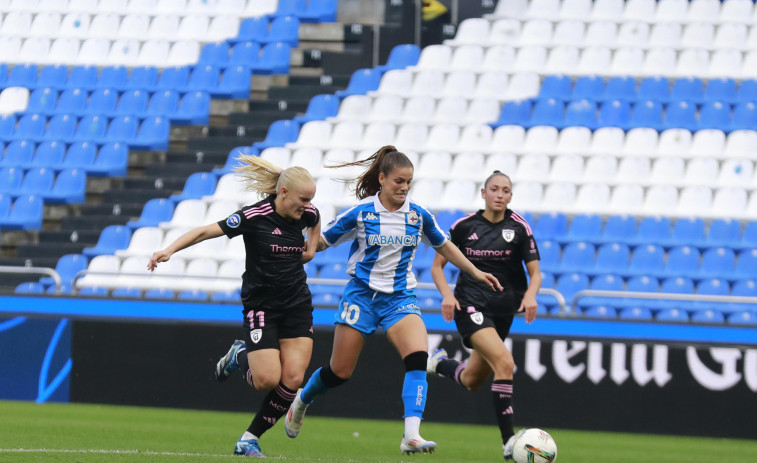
[242,288,313,352]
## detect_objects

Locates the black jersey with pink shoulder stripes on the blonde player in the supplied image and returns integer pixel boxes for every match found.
[218,195,320,302]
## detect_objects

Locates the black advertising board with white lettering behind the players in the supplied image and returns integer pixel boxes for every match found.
[70,321,757,438]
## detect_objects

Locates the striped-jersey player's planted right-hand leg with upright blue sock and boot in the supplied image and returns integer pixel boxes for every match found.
[386,314,436,453]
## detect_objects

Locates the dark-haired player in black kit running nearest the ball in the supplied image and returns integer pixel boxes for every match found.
[428,170,541,460]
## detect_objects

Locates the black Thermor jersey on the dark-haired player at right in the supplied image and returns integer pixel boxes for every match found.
[450,209,539,312]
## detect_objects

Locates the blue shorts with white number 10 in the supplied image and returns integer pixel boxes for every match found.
[334,279,421,336]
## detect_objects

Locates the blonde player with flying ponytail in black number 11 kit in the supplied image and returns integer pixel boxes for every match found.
[147,155,321,457]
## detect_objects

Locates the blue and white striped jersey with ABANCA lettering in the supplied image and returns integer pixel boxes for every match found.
[322,195,447,293]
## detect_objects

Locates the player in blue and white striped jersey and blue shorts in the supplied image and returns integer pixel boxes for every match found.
[284,146,501,453]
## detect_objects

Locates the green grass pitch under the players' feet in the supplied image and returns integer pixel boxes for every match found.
[0,401,757,463]
